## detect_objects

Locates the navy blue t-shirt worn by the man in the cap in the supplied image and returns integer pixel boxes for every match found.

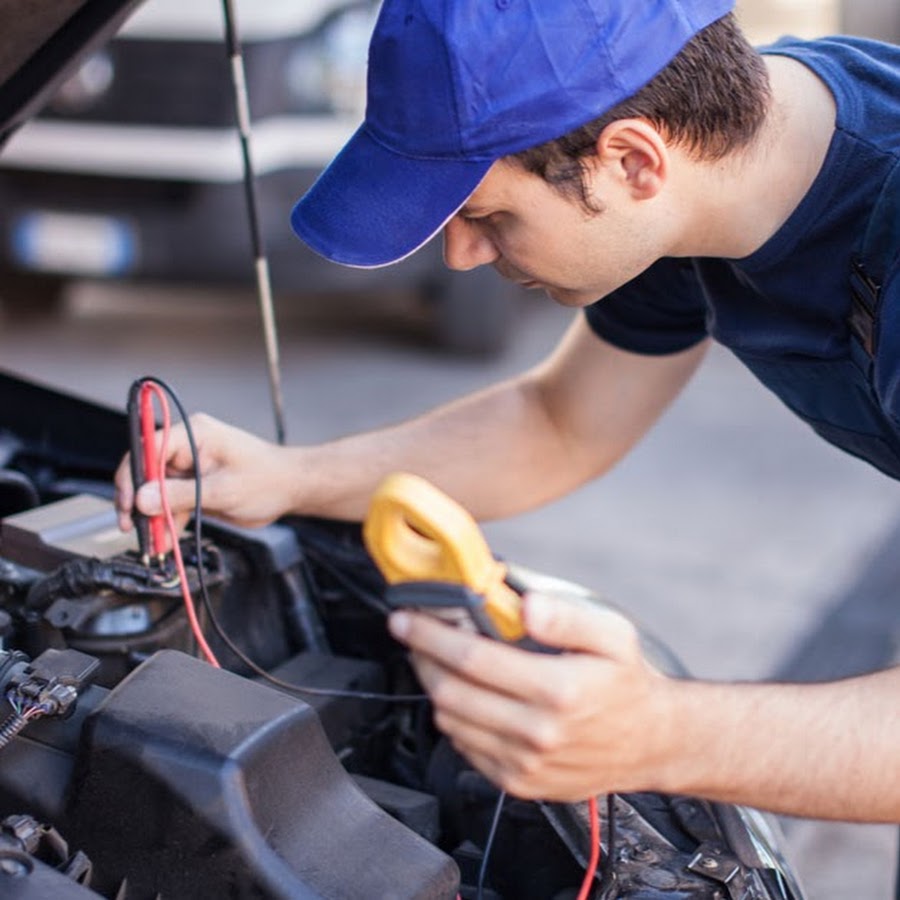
[586,37,900,478]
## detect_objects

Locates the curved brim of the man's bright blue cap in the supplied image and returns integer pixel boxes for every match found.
[291,125,492,268]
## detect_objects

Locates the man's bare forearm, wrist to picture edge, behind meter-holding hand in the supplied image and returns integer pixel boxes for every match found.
[659,669,900,822]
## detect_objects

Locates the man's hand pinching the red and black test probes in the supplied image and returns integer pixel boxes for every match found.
[115,413,296,544]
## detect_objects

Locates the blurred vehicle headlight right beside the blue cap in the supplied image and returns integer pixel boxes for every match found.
[285,3,378,117]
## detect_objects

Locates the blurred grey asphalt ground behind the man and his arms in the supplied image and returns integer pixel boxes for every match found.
[0,284,900,900]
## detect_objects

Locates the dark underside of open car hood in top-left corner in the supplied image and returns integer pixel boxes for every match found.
[0,0,141,147]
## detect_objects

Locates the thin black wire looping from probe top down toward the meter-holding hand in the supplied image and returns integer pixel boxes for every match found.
[132,377,428,703]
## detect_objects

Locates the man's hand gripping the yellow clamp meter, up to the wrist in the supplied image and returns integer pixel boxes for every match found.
[390,595,671,802]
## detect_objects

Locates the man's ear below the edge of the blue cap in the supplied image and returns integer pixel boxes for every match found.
[592,118,670,200]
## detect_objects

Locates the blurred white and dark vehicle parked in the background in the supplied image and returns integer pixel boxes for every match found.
[0,0,519,353]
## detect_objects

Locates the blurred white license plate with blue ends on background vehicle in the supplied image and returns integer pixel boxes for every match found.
[12,211,136,275]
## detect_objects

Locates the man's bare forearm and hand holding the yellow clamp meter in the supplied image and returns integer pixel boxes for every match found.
[392,597,900,822]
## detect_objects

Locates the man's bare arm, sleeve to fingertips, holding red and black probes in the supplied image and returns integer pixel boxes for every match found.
[116,316,705,528]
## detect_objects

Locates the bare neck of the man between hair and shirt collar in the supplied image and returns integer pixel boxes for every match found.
[671,56,835,259]
